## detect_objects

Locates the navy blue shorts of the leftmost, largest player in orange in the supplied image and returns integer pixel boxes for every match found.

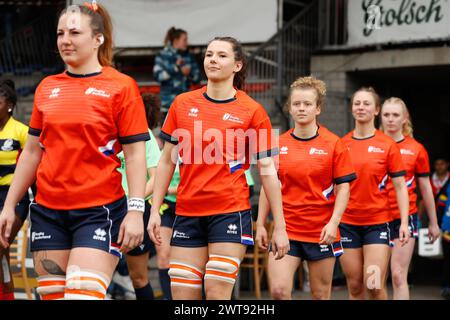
[30,197,128,257]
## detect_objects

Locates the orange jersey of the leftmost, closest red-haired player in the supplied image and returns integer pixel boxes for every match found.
[29,67,149,210]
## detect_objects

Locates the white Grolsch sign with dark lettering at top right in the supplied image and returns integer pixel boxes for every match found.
[348,0,450,46]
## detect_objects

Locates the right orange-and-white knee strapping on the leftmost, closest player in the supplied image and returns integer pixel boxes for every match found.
[64,270,109,300]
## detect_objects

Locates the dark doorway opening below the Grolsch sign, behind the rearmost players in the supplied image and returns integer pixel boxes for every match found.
[349,66,450,161]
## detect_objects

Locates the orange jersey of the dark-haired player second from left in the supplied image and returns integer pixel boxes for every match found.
[160,87,278,216]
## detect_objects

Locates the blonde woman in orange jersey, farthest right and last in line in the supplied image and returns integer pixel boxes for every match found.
[381,97,440,300]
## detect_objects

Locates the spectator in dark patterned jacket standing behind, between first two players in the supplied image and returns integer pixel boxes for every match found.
[153,27,200,121]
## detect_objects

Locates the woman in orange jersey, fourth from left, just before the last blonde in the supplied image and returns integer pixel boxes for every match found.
[339,88,409,299]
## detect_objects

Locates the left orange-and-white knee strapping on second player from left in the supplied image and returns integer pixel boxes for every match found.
[169,261,203,288]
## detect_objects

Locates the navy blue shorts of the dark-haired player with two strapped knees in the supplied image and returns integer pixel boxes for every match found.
[170,210,254,248]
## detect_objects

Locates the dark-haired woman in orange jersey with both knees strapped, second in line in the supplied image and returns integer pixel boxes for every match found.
[148,37,289,299]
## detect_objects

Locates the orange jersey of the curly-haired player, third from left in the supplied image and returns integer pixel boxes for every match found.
[278,127,356,243]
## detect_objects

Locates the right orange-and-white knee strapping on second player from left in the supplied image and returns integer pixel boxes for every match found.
[205,254,241,284]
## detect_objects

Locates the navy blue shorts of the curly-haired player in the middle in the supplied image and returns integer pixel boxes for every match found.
[287,240,344,261]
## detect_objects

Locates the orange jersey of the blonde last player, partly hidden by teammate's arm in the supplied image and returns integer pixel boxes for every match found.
[386,137,430,220]
